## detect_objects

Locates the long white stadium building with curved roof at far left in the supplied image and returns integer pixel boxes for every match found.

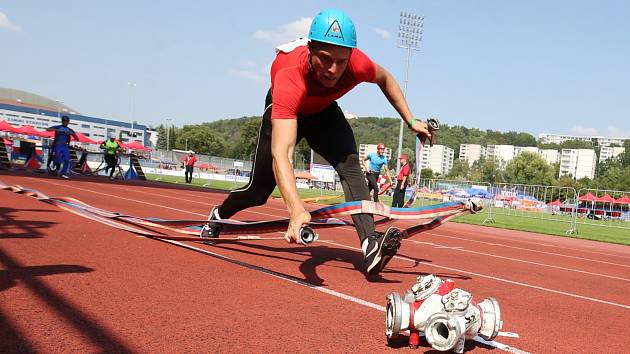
[0,88,149,146]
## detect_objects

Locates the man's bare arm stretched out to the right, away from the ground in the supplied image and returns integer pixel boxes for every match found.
[373,63,431,138]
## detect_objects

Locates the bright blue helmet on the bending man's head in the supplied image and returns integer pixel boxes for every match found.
[308,9,357,48]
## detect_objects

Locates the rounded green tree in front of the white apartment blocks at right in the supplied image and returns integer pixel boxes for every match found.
[505,152,555,186]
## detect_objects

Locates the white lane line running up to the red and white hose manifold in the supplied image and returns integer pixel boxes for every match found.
[157,238,529,354]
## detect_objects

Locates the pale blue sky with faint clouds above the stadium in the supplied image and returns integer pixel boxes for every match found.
[0,0,630,137]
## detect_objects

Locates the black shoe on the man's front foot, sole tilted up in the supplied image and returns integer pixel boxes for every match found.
[361,227,403,275]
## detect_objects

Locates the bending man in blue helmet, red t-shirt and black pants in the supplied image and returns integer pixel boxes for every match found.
[200,9,430,274]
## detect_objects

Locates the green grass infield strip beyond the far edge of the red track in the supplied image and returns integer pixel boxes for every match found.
[147,174,630,245]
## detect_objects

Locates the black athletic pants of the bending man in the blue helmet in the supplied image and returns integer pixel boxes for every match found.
[219,92,374,241]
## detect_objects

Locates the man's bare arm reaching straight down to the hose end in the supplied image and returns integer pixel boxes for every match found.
[271,119,311,243]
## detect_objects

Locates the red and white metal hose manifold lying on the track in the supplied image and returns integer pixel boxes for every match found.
[385,274,503,353]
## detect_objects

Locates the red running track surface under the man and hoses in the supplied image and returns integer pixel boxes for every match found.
[0,173,630,353]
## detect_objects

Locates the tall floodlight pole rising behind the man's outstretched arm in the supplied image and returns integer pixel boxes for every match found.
[396,11,424,170]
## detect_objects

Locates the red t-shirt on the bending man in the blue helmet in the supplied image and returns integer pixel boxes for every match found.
[271,45,376,119]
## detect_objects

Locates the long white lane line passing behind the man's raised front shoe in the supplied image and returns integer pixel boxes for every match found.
[30,180,630,309]
